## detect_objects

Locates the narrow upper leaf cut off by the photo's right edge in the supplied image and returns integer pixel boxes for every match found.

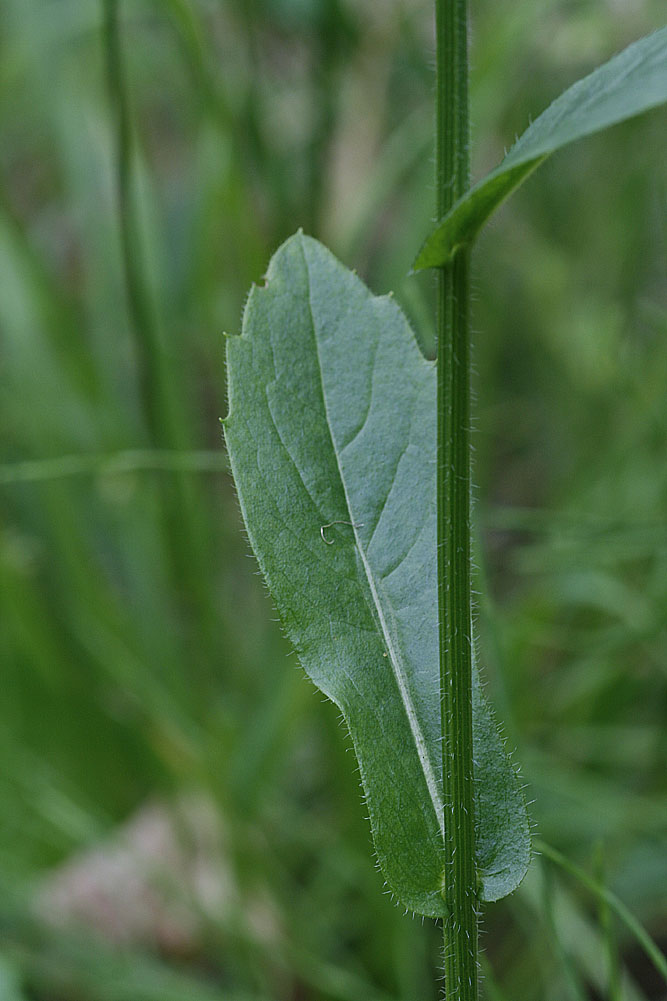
[414,27,667,270]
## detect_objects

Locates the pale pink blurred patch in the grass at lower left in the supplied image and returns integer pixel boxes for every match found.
[35,796,279,953]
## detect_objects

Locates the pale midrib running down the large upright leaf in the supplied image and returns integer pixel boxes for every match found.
[299,237,445,840]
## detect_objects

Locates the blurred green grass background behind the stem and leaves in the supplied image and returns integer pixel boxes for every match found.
[0,0,667,1001]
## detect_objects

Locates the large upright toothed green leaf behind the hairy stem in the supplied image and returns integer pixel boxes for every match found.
[224,233,530,917]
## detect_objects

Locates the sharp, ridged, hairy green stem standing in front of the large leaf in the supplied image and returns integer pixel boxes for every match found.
[436,0,478,1001]
